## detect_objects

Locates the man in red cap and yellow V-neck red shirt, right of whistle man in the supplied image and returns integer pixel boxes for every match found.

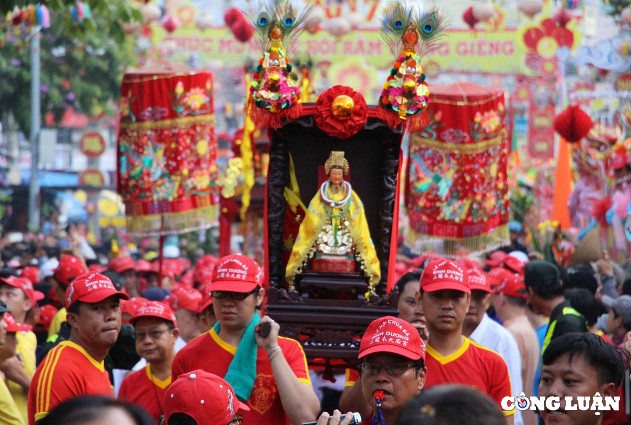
[417,259,514,424]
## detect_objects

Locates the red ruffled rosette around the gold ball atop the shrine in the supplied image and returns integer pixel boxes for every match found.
[315,86,368,139]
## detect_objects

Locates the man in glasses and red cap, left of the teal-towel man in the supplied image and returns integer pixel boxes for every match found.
[118,301,180,423]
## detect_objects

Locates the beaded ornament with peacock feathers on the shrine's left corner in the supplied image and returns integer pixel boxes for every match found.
[248,1,305,128]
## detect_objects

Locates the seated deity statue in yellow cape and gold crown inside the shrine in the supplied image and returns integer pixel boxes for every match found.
[286,151,380,292]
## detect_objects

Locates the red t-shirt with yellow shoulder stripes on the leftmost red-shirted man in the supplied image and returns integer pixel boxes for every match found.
[28,341,114,425]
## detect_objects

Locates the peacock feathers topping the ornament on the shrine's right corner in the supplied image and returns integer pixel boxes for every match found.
[382,2,446,57]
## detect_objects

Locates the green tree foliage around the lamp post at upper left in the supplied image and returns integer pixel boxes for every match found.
[0,11,133,134]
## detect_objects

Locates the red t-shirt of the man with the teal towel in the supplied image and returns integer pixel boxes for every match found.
[171,329,311,425]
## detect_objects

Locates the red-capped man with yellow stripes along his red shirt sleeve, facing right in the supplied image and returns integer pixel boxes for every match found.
[28,272,128,425]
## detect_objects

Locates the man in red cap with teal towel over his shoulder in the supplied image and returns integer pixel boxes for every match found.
[172,255,320,425]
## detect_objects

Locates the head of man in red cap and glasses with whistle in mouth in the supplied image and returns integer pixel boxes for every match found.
[358,316,425,425]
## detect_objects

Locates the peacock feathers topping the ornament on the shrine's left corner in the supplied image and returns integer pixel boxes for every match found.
[249,0,311,51]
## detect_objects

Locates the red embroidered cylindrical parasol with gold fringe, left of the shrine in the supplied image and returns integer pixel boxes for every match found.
[117,72,218,236]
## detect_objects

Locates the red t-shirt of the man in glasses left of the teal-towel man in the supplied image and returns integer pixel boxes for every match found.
[118,365,171,424]
